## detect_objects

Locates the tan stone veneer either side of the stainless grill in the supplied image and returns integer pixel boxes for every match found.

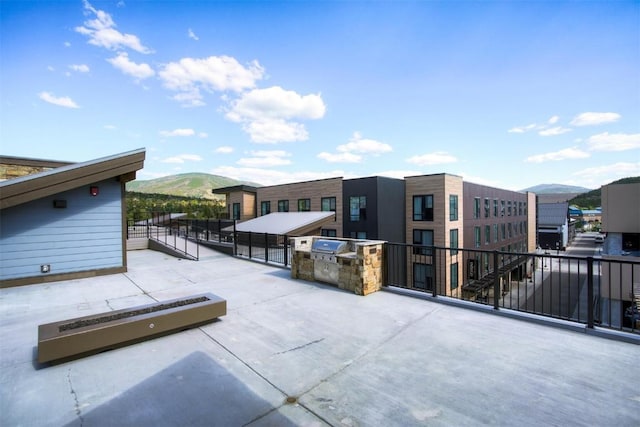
[291,236,384,295]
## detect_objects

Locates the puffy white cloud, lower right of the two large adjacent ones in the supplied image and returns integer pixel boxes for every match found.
[225,86,326,143]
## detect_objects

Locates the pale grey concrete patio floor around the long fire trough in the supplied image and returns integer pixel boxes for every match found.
[0,249,640,426]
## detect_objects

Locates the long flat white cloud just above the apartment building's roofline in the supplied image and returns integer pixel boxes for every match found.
[211,166,348,185]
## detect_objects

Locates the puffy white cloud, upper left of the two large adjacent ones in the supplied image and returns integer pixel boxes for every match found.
[158,56,264,106]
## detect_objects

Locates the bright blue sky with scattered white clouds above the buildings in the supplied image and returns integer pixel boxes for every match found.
[0,0,640,190]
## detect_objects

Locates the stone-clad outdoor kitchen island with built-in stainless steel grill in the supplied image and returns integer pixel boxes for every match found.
[291,236,384,295]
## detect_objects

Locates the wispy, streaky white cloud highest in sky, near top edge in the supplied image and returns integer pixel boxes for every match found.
[75,0,153,53]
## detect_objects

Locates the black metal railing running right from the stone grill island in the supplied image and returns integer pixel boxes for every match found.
[385,243,640,333]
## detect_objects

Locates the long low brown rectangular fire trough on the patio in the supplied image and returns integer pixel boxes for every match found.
[38,293,227,363]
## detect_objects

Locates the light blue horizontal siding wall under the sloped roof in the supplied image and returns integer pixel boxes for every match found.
[0,179,123,280]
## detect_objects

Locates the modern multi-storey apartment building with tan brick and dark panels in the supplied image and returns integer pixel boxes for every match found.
[213,173,536,294]
